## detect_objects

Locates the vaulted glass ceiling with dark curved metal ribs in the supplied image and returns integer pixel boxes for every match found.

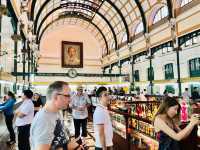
[30,0,173,53]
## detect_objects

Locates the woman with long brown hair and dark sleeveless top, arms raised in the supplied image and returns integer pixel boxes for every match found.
[154,97,200,150]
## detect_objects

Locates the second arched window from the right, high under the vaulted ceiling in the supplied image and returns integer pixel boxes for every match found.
[153,6,168,24]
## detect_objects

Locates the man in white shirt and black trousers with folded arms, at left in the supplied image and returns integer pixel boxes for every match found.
[15,90,34,150]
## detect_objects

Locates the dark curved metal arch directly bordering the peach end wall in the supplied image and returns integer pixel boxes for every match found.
[37,11,109,54]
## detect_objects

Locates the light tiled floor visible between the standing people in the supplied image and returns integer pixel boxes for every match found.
[0,114,94,150]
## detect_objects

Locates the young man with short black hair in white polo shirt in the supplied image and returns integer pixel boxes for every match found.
[93,87,113,150]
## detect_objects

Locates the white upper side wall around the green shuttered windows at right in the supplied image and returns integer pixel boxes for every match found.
[119,44,200,95]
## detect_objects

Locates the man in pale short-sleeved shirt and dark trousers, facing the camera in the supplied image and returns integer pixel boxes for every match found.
[70,86,90,142]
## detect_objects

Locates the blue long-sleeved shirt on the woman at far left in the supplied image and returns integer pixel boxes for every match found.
[0,98,16,116]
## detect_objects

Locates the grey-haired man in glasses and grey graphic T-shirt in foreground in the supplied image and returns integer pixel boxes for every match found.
[30,81,79,150]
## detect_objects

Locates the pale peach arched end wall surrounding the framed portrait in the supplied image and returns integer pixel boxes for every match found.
[36,25,102,82]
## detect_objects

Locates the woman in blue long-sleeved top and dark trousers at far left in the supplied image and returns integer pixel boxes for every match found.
[0,91,16,145]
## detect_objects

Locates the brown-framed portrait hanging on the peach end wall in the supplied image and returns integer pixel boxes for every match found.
[61,41,83,68]
